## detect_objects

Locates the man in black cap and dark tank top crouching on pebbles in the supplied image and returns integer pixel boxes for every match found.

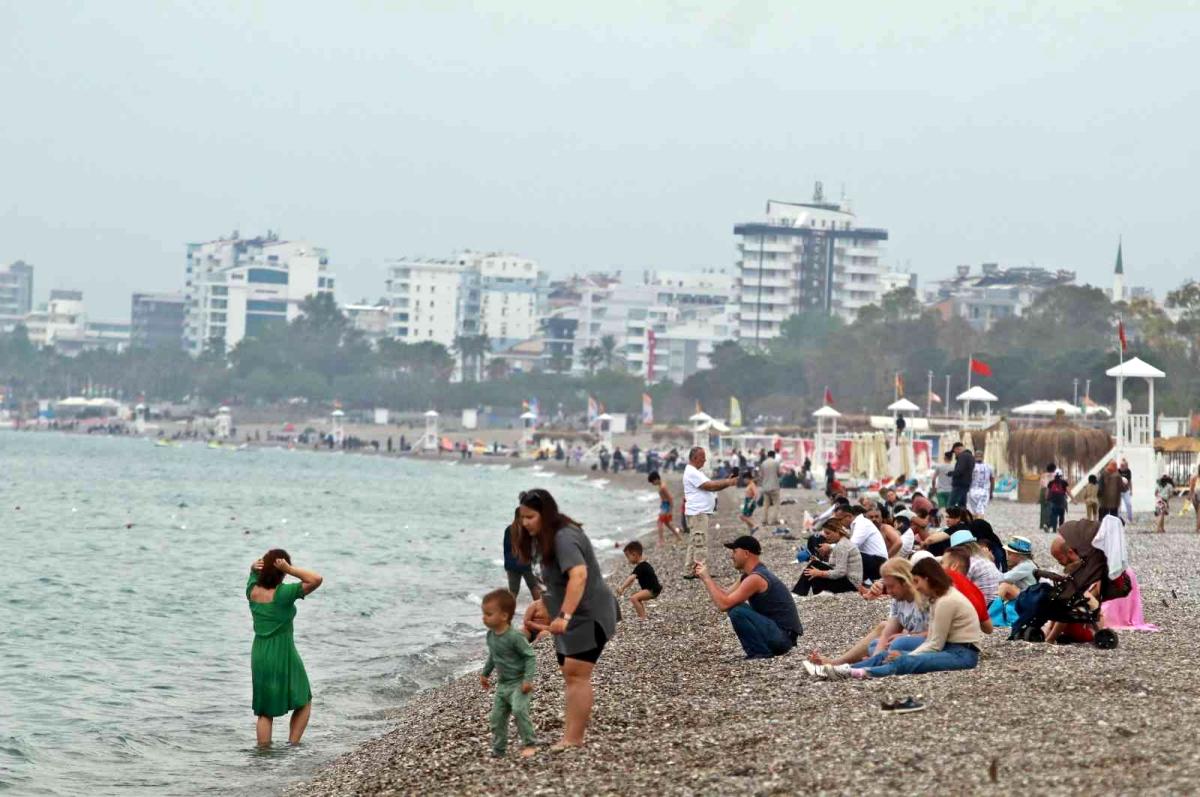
[696,535,804,659]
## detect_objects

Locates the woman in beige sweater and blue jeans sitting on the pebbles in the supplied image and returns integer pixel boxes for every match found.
[804,557,983,681]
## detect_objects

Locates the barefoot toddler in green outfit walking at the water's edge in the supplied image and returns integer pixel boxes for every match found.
[479,589,536,757]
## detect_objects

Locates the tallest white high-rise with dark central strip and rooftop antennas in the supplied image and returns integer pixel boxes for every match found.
[733,182,888,342]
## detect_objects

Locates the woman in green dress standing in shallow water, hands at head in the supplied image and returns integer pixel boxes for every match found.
[246,549,322,747]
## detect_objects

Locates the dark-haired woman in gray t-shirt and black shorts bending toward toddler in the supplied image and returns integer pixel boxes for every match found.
[512,489,620,748]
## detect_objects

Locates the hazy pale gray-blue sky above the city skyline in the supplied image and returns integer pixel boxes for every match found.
[0,0,1200,319]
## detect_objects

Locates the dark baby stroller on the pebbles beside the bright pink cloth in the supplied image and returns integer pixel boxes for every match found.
[1008,520,1130,649]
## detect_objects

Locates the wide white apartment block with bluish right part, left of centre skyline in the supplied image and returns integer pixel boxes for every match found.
[386,250,545,350]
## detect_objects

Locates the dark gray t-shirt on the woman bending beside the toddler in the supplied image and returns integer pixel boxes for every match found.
[541,526,620,655]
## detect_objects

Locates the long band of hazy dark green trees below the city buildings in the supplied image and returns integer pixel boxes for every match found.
[0,282,1200,424]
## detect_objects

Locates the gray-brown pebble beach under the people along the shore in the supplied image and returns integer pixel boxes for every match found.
[284,474,1200,797]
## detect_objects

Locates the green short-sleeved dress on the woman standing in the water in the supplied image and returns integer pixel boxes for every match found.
[246,571,312,717]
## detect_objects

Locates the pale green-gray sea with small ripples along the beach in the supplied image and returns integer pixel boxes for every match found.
[0,431,656,797]
